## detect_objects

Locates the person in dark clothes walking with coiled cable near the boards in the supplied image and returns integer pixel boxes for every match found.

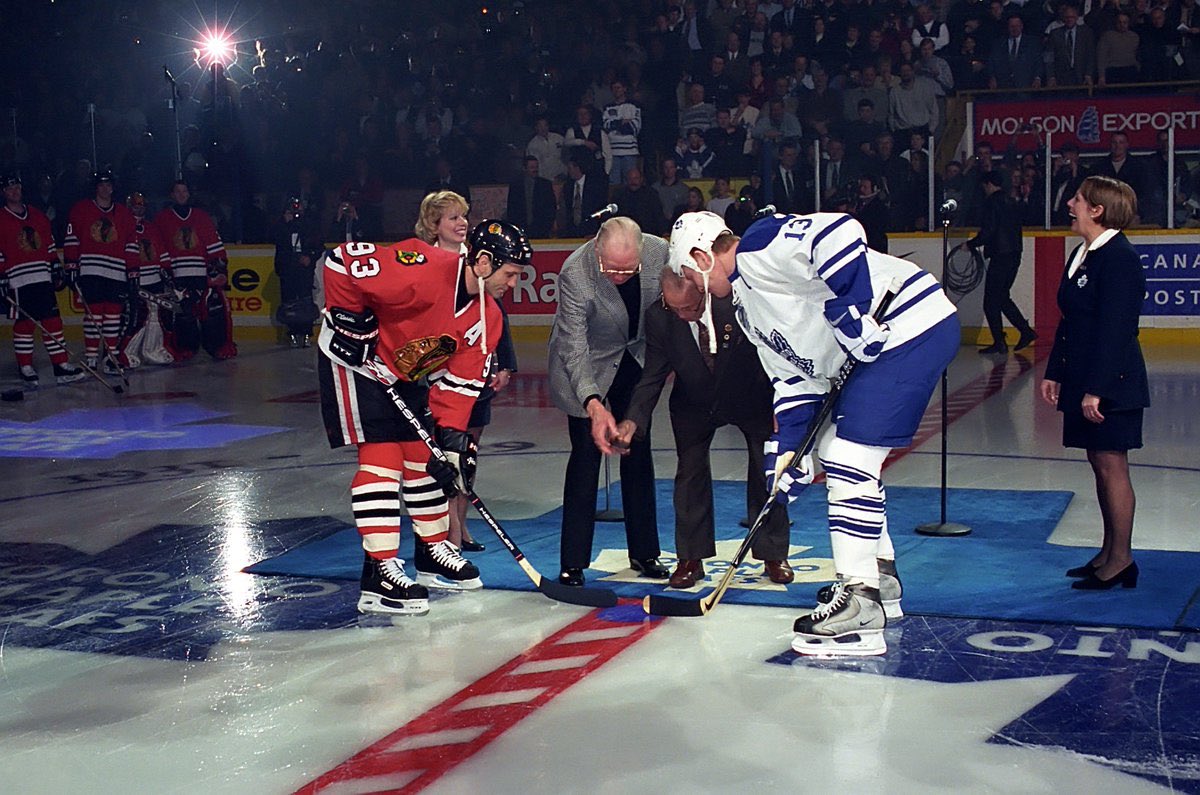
[959,171,1038,354]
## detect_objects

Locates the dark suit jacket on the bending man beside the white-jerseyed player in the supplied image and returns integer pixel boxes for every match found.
[626,297,773,435]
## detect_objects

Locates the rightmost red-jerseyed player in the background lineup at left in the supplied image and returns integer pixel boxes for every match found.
[154,180,238,361]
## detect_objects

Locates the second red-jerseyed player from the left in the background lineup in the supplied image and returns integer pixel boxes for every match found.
[62,171,133,372]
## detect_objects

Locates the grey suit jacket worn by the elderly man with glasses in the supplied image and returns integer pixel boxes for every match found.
[547,233,667,417]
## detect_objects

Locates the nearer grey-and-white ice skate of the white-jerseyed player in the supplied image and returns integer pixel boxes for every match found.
[792,581,888,657]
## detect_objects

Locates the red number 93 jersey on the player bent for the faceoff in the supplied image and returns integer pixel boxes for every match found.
[324,238,504,430]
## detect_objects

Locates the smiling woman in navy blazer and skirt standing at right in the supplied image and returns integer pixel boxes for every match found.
[1040,177,1150,591]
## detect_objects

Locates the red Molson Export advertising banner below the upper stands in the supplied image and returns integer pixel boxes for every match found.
[974,95,1200,151]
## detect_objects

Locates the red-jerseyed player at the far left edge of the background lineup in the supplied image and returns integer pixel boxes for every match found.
[0,174,86,388]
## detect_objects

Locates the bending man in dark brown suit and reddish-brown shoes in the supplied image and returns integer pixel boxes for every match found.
[618,270,794,588]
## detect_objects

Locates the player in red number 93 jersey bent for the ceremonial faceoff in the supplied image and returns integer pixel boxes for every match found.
[317,221,533,615]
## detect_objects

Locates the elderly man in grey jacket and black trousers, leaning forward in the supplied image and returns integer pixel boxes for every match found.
[547,217,670,586]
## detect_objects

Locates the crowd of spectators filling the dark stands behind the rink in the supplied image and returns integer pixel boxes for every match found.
[0,0,1200,243]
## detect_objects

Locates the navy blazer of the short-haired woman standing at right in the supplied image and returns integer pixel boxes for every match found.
[1045,233,1150,411]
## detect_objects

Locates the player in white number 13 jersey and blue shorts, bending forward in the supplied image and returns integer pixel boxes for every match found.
[668,213,959,656]
